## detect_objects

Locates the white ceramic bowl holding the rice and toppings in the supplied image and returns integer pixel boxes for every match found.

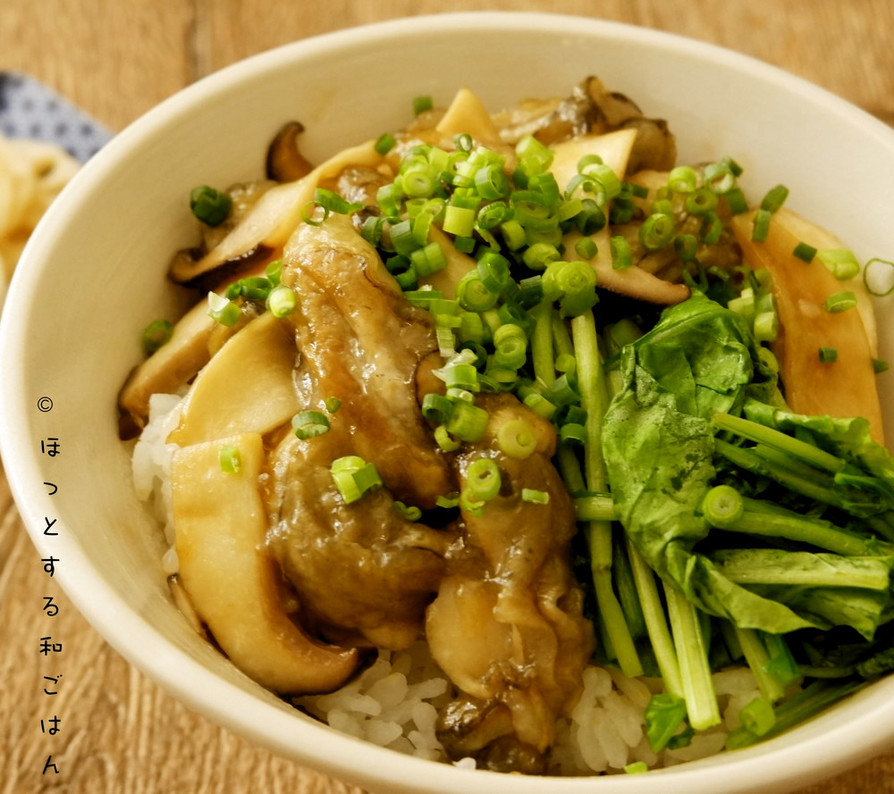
[0,13,894,794]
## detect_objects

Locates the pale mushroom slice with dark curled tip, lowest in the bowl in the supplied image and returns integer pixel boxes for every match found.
[171,433,359,693]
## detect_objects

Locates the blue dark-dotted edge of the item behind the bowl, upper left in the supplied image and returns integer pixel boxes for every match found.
[0,72,112,162]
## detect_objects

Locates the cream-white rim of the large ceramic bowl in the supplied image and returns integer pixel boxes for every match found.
[0,11,894,794]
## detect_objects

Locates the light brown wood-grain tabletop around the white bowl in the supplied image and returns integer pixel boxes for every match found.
[0,0,894,794]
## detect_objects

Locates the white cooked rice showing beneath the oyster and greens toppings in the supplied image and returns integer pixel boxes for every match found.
[132,394,760,776]
